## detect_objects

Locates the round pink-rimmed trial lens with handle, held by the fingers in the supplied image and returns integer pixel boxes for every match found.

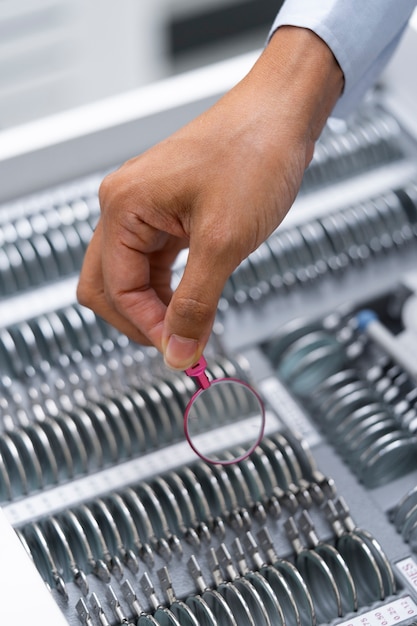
[184,356,265,465]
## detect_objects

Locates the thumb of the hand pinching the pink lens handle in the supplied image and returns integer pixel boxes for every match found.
[162,245,234,370]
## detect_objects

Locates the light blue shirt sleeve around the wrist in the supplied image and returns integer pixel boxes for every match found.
[270,0,417,117]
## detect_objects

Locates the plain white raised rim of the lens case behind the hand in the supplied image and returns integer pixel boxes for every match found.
[0,53,257,203]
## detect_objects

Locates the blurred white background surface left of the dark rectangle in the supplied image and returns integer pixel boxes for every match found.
[0,0,175,128]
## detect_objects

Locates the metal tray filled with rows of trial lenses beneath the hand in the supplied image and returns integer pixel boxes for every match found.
[0,99,417,626]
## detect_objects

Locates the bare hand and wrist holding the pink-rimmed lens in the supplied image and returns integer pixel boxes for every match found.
[77,26,343,369]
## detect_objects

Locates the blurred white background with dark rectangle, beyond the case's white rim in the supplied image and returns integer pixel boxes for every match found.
[0,0,282,128]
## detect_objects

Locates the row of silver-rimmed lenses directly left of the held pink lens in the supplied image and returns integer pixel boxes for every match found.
[0,372,182,502]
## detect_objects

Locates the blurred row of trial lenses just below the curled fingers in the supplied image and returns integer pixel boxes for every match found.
[0,304,161,428]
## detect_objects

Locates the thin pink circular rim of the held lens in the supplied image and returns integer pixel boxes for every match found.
[184,377,266,465]
